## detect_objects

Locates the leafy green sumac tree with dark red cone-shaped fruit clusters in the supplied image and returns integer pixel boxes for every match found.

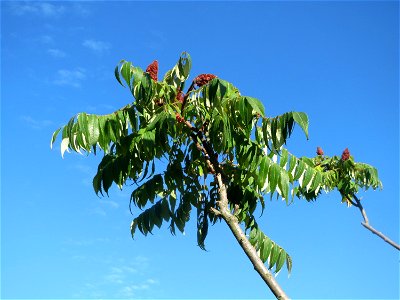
[51,52,396,299]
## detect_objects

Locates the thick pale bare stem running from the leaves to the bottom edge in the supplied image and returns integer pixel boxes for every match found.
[215,173,289,299]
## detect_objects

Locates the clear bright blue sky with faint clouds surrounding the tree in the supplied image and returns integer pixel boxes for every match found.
[0,1,399,299]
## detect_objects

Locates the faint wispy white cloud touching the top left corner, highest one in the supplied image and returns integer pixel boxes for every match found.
[11,1,65,17]
